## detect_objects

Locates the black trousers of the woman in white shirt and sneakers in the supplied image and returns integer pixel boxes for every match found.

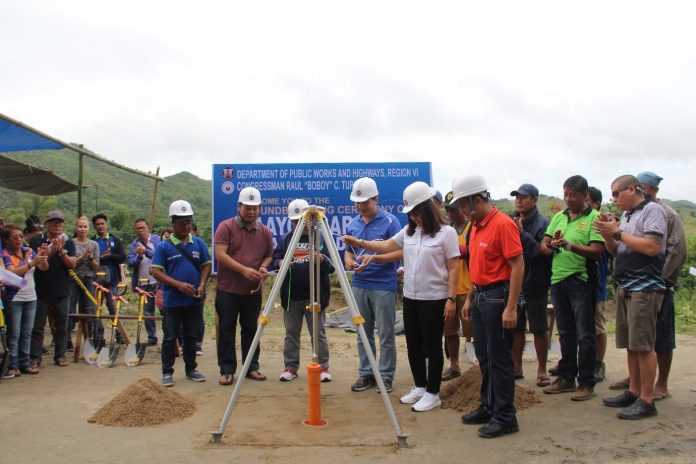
[404,297,447,394]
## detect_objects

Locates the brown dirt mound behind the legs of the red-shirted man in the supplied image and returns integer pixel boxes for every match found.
[440,366,541,411]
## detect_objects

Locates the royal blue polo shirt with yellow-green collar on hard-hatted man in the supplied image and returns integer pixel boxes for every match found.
[150,234,211,309]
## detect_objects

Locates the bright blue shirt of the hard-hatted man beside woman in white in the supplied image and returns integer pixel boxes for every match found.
[348,209,401,292]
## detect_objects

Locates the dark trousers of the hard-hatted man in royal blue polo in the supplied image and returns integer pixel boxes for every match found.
[162,305,202,374]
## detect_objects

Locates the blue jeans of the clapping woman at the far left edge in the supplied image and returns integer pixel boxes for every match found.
[6,300,36,369]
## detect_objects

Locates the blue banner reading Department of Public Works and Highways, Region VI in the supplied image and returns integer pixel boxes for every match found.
[211,162,432,264]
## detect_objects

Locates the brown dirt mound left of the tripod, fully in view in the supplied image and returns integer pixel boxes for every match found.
[87,378,196,427]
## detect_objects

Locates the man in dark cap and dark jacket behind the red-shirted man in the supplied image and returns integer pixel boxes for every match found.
[510,184,551,387]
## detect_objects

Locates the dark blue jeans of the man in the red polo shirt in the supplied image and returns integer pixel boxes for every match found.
[471,285,515,425]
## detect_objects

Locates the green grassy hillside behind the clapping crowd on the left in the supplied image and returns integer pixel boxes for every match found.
[0,150,212,242]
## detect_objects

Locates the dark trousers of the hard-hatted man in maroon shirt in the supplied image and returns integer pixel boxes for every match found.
[215,290,261,375]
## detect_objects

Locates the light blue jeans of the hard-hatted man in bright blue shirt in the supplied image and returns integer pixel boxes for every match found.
[353,287,396,380]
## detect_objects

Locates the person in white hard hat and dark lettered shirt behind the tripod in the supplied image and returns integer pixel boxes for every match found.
[273,199,335,382]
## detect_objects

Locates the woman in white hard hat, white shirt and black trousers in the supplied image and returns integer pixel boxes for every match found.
[343,182,460,412]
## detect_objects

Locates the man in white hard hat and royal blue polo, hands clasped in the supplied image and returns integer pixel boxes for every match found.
[150,200,212,387]
